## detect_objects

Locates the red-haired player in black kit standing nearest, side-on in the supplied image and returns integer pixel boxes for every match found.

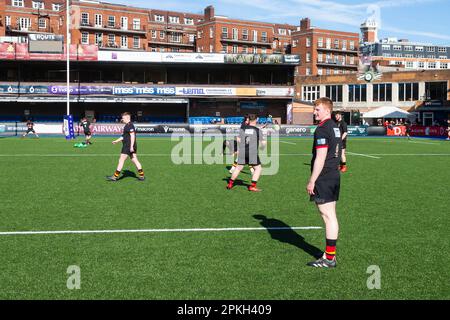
[306,98,342,268]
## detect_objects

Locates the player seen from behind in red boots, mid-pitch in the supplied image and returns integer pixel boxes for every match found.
[227,114,267,192]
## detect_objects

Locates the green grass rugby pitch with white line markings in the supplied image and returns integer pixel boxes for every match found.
[0,138,450,299]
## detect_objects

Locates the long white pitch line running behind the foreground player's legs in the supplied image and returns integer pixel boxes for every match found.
[0,227,322,236]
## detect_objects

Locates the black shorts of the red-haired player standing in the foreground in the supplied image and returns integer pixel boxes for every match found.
[310,168,341,204]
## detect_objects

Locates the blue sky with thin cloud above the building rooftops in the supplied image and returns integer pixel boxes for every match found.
[104,0,450,45]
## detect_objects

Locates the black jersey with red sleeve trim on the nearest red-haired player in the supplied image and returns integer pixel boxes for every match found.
[311,119,342,171]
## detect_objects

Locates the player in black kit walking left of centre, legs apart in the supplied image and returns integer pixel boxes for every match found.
[107,112,145,181]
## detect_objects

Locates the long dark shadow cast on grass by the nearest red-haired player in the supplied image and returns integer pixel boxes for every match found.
[253,214,323,259]
